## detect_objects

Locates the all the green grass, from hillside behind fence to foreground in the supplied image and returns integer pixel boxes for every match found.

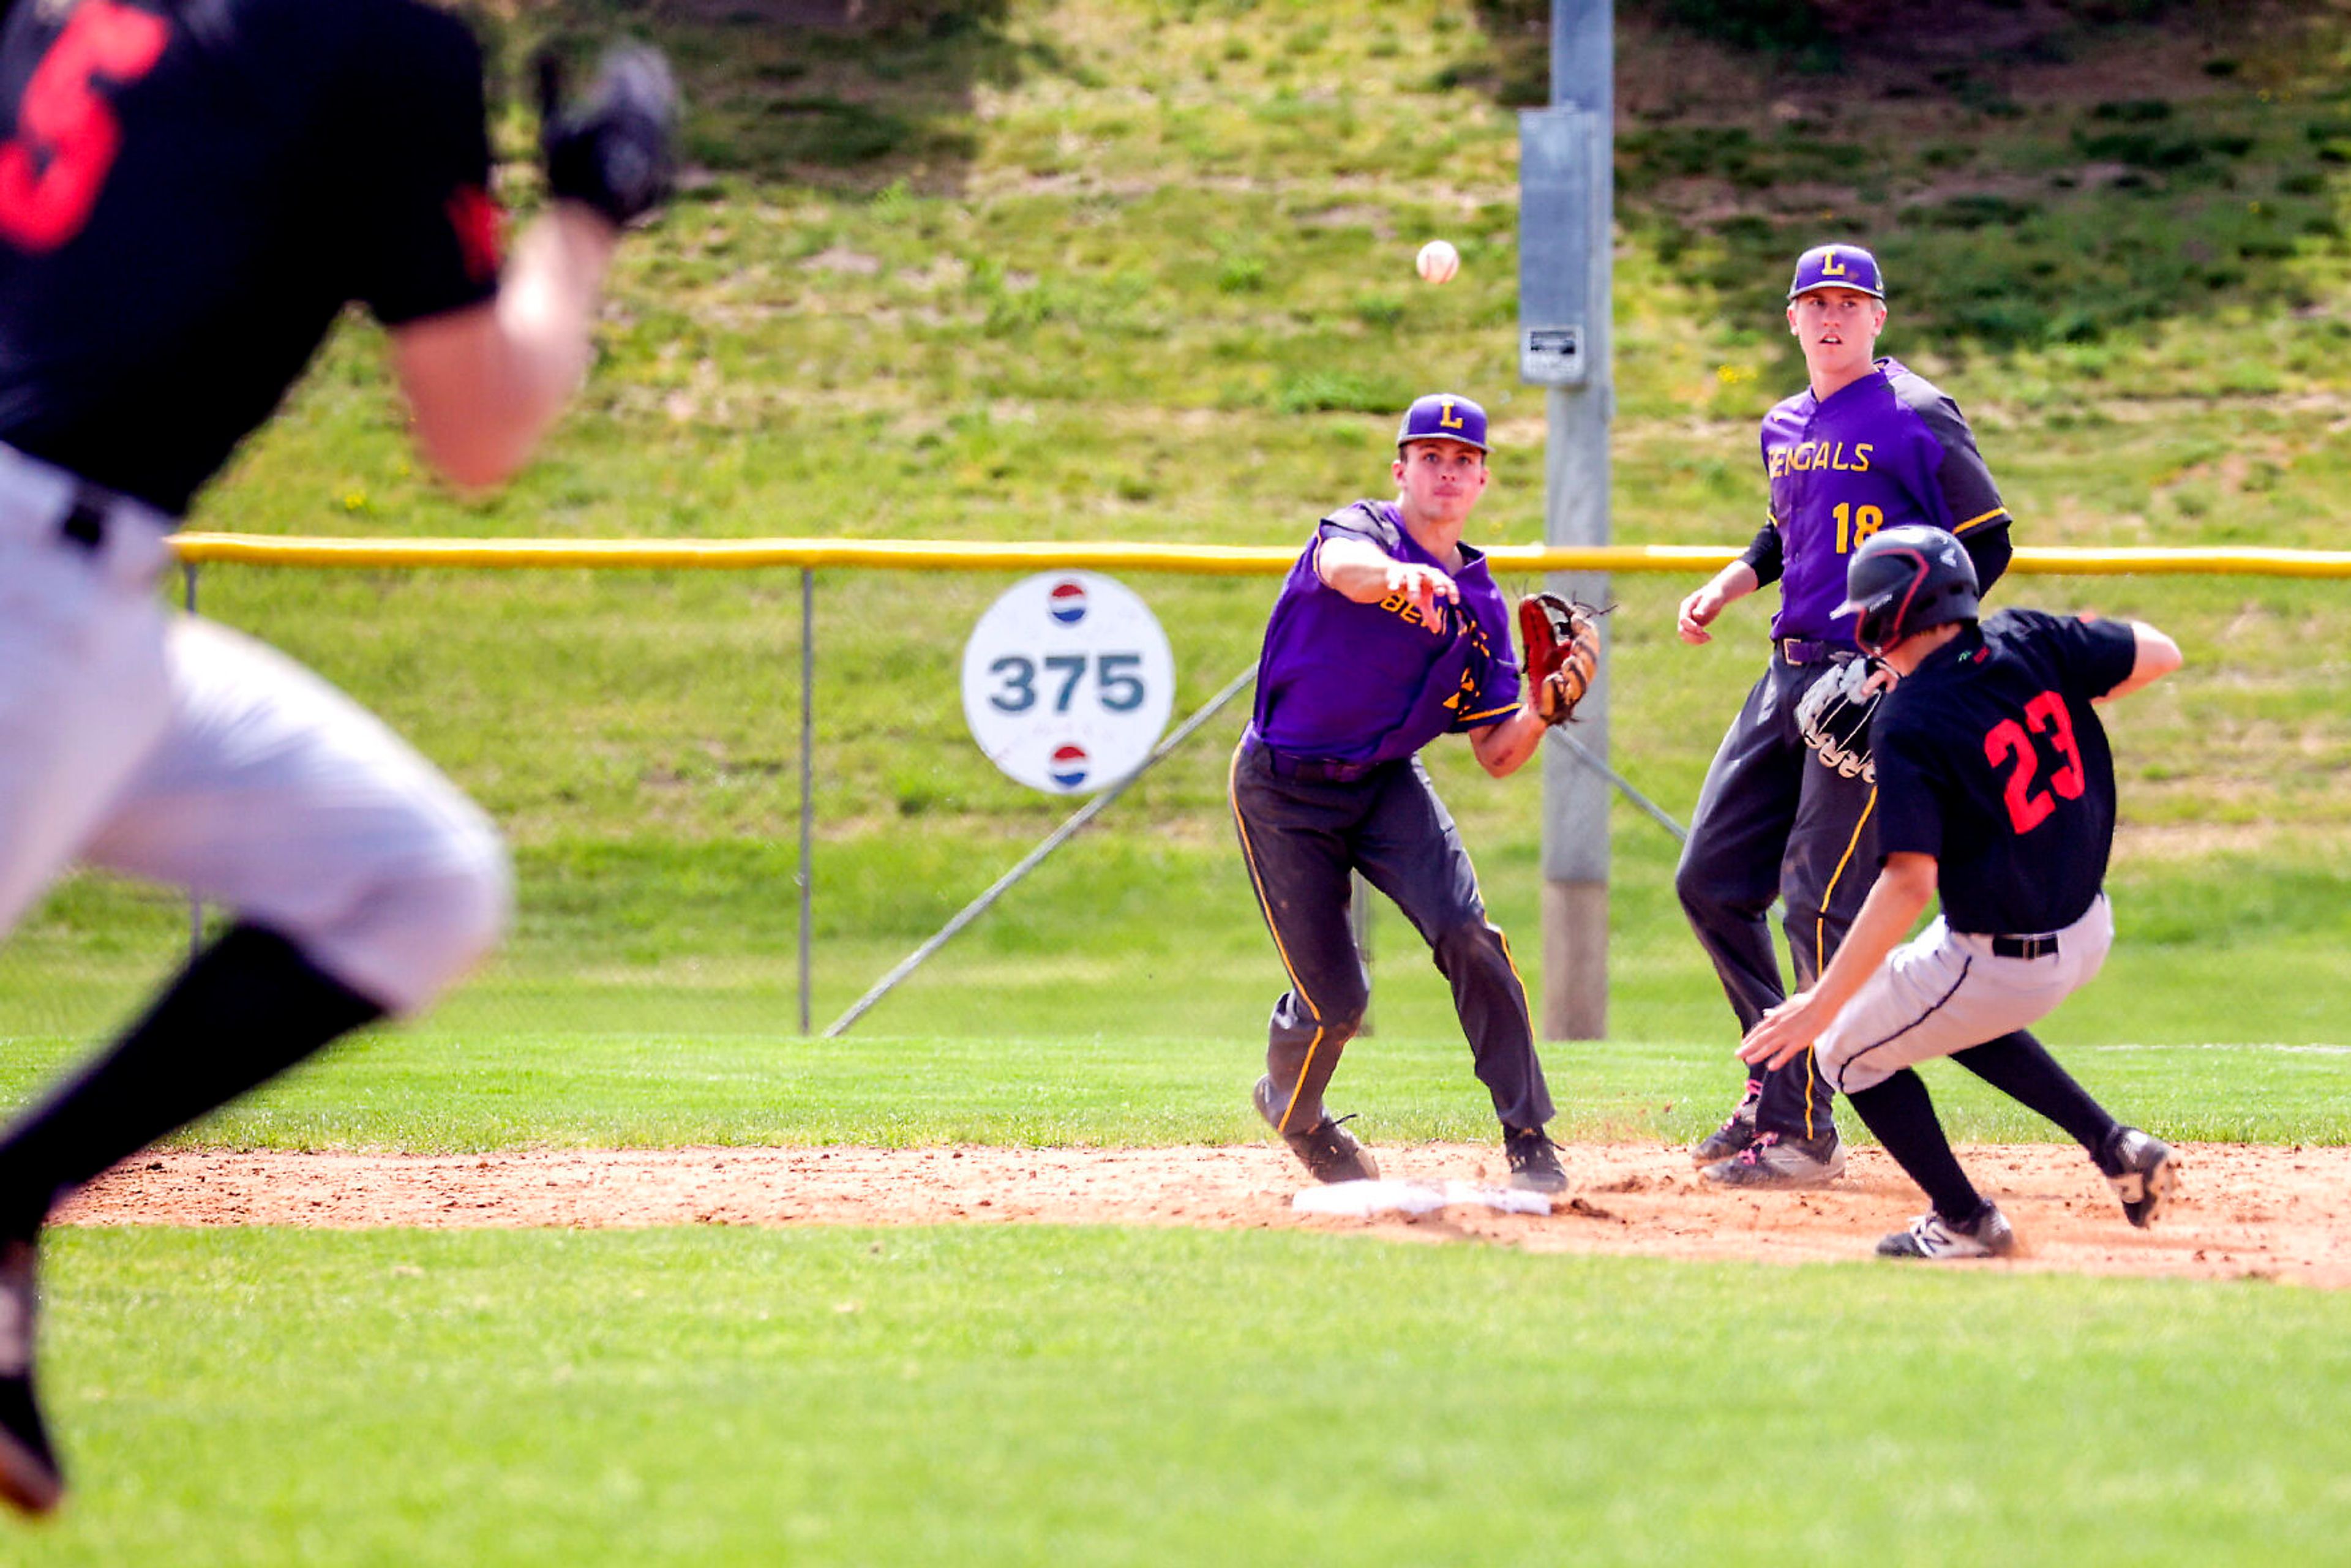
[0,0,2351,1568]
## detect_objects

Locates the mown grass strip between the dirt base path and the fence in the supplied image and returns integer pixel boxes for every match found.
[13,1027,2351,1152]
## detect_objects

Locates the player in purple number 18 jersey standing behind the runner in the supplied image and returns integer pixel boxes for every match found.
[1674,244,2008,1187]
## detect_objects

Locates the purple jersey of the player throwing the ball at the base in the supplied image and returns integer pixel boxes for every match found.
[1251,501,1519,762]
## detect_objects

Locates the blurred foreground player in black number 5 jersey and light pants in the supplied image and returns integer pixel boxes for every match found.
[0,0,675,1512]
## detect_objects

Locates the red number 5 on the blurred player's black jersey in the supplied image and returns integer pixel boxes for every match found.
[0,0,169,252]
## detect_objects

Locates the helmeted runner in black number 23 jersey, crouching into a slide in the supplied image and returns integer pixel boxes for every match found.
[1740,527,2180,1258]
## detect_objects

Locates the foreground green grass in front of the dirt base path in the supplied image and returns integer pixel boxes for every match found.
[0,1227,2351,1568]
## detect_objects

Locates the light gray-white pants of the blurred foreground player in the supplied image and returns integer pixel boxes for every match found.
[0,447,510,1013]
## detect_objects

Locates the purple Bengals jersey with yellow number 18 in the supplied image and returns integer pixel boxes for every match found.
[1749,359,2008,644]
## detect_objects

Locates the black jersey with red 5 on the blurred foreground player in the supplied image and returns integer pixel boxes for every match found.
[0,0,498,515]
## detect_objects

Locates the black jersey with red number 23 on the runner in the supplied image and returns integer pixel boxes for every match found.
[1869,609,2137,936]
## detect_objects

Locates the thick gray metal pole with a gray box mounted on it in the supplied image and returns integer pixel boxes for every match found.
[1519,0,1615,1039]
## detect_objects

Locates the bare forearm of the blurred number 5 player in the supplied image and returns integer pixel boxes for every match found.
[392,202,618,487]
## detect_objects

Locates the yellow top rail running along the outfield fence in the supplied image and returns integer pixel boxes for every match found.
[171,534,2351,579]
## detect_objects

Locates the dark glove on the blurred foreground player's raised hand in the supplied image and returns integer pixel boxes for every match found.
[538,45,677,228]
